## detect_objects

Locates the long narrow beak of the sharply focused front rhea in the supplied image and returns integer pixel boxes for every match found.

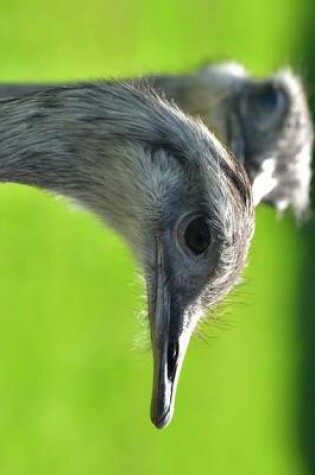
[150,244,191,429]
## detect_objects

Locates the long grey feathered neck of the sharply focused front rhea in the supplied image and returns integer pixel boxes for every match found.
[0,83,202,251]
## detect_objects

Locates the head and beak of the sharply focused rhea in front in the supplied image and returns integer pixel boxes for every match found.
[106,91,253,428]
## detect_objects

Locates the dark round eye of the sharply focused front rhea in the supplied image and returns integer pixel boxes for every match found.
[183,216,211,256]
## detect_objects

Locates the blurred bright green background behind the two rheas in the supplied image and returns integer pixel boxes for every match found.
[0,0,315,475]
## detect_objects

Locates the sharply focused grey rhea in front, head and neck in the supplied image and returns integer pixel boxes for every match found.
[0,81,255,429]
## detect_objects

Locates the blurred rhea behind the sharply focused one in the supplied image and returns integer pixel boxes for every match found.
[0,62,314,222]
